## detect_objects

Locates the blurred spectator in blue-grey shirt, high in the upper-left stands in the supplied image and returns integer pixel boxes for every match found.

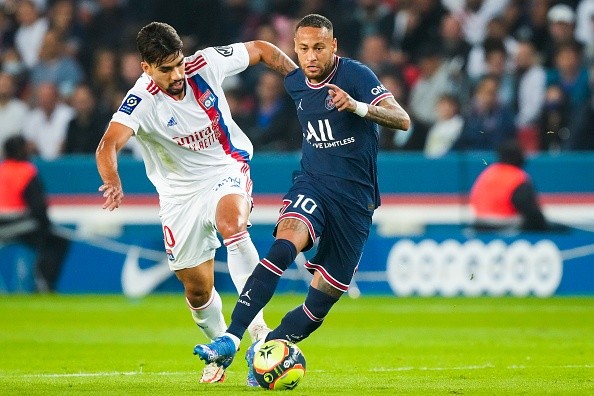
[30,29,84,99]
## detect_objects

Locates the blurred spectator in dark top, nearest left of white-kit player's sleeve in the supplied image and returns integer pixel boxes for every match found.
[62,84,111,154]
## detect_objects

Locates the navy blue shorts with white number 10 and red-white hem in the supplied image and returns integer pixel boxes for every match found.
[274,175,373,292]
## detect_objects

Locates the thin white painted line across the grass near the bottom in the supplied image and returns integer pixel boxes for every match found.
[6,364,594,378]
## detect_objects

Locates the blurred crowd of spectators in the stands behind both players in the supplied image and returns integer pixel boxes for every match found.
[0,0,594,160]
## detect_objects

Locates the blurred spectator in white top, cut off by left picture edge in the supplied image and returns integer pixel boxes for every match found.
[0,72,29,152]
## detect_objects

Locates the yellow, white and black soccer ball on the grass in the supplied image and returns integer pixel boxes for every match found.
[253,340,305,390]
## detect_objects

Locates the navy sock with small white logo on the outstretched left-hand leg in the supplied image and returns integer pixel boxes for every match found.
[227,239,297,339]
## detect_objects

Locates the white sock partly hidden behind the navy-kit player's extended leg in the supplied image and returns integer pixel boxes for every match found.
[223,231,269,341]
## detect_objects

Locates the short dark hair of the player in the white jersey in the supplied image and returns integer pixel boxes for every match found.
[136,22,184,66]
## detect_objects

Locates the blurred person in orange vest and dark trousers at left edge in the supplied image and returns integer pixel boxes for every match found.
[0,136,69,292]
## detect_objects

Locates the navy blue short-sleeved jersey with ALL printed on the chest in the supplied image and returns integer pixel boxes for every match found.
[285,56,392,210]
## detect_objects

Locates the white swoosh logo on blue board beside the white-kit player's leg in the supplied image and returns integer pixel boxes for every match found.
[122,246,173,298]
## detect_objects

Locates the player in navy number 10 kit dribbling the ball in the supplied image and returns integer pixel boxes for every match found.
[194,14,410,386]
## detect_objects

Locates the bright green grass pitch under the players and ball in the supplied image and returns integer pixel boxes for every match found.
[0,294,594,396]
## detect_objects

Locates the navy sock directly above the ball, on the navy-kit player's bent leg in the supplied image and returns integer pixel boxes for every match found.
[266,286,338,342]
